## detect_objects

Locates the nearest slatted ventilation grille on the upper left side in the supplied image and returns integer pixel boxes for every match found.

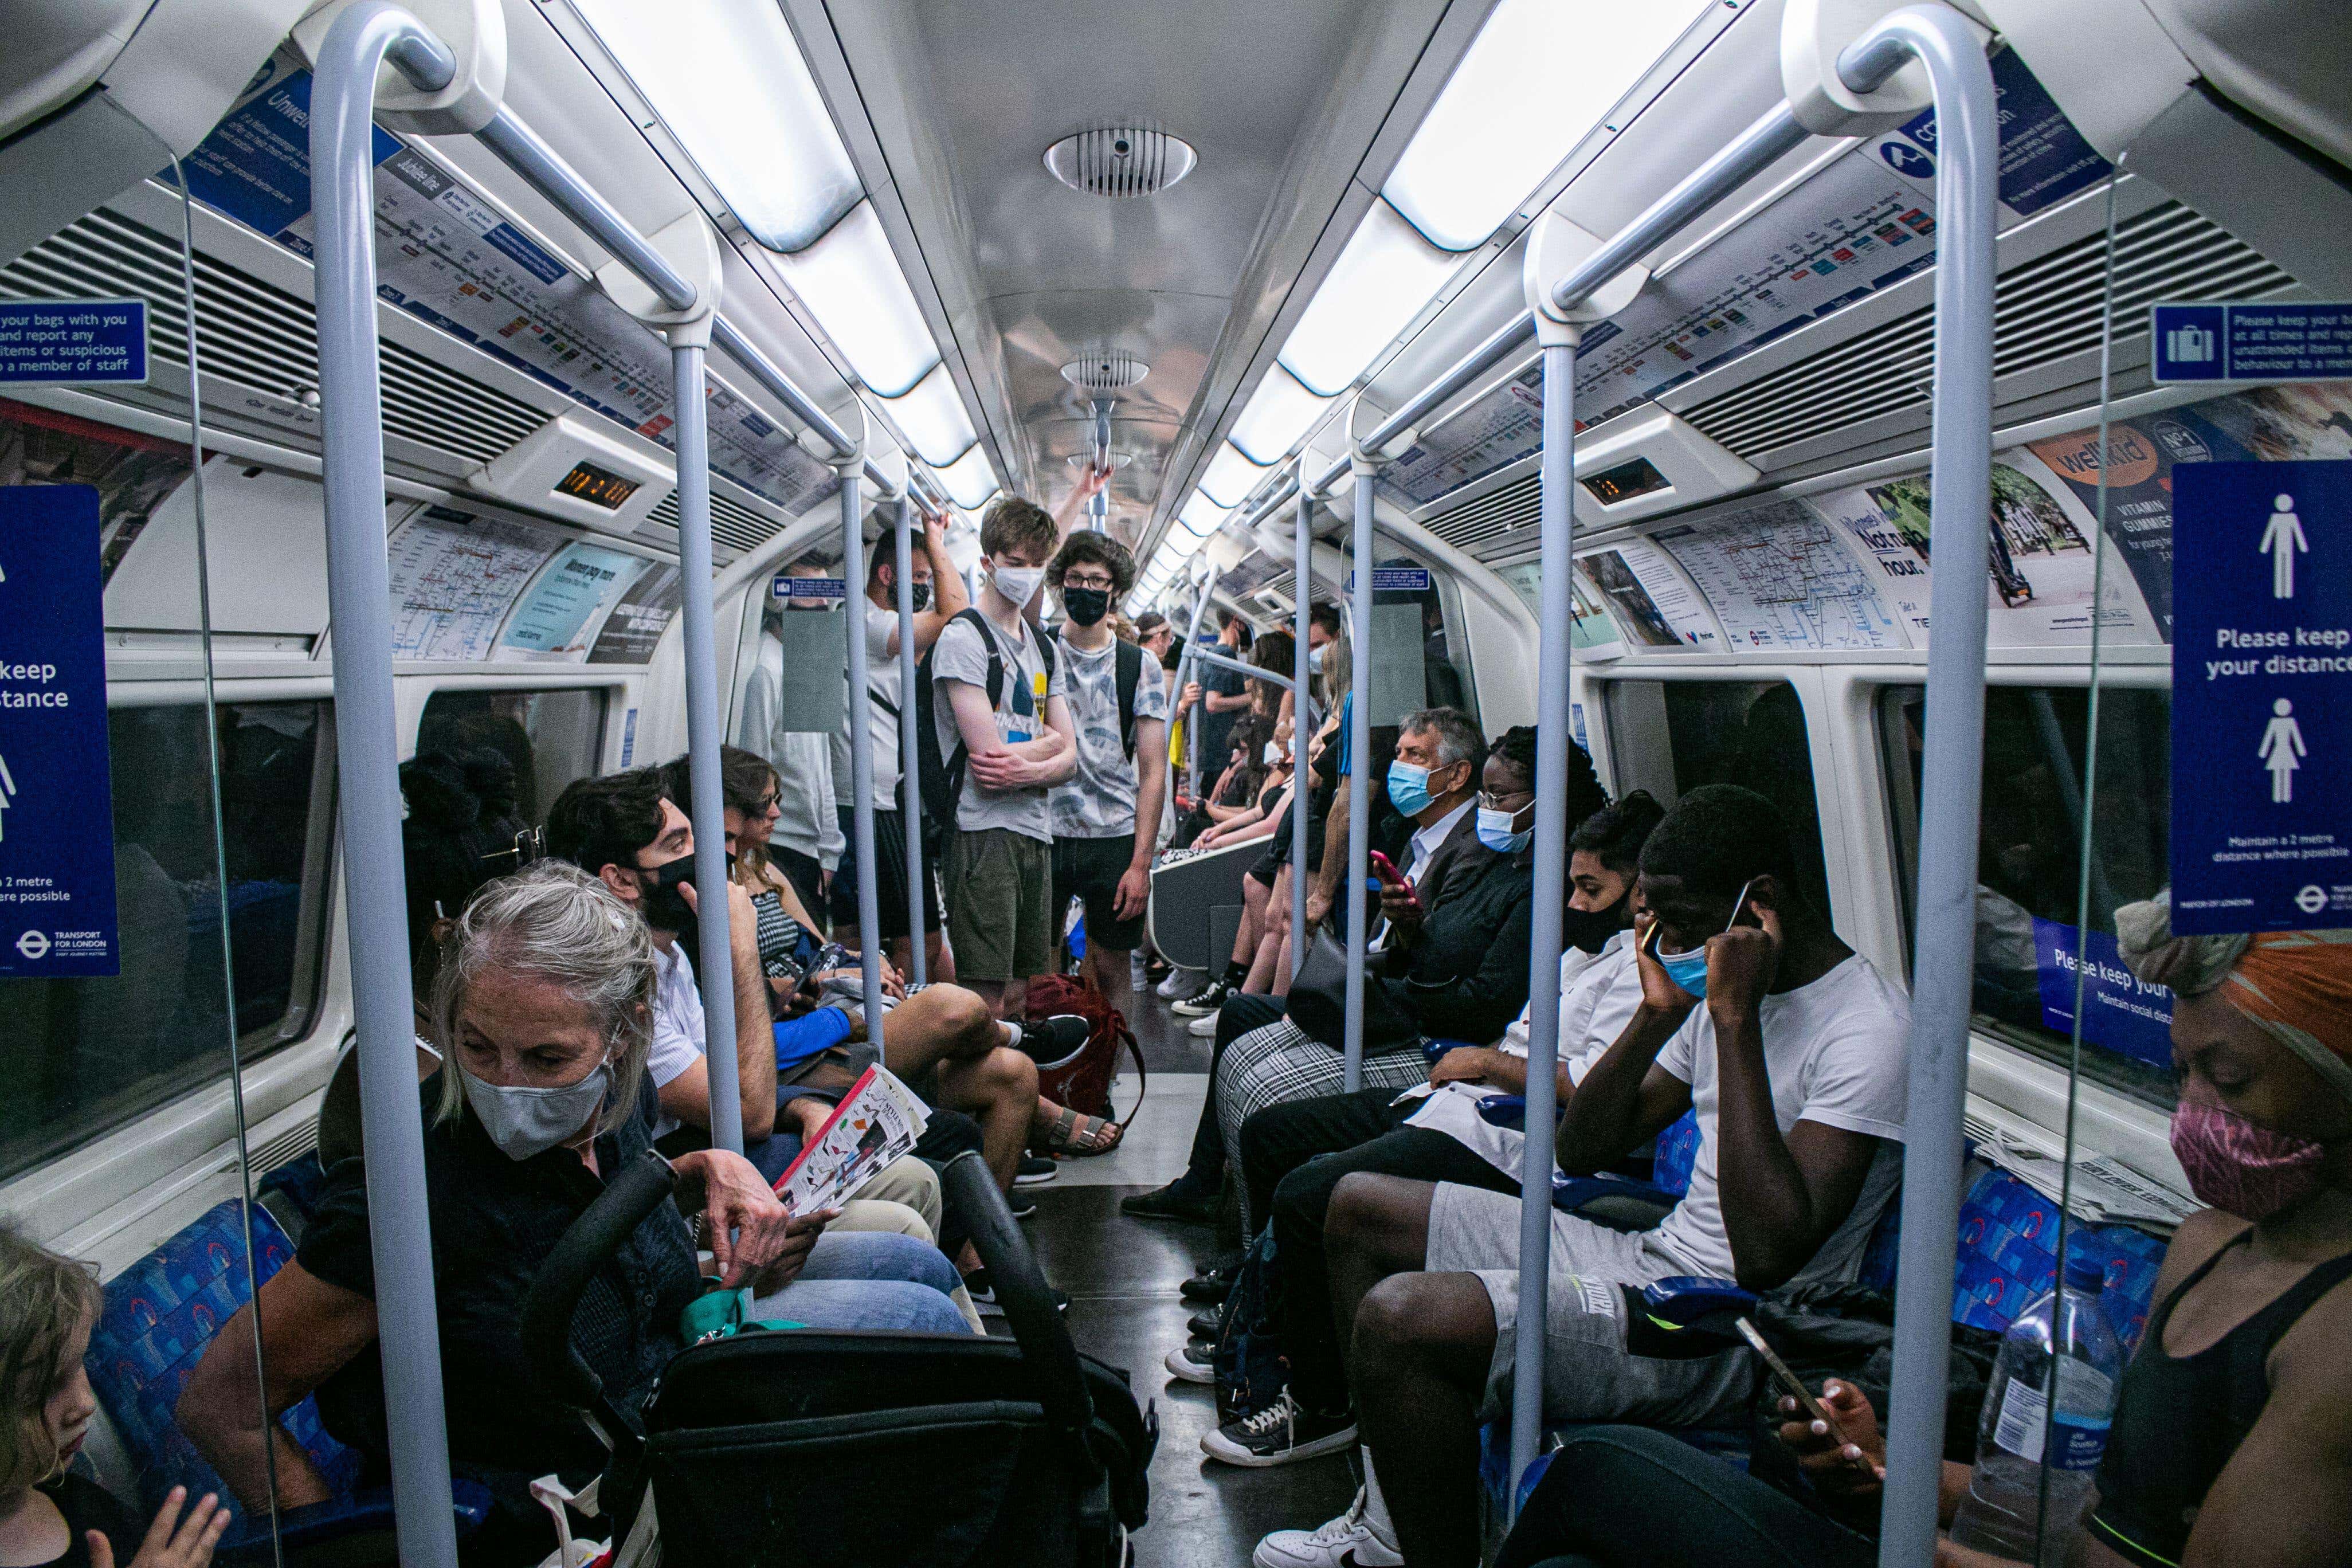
[0,211,548,463]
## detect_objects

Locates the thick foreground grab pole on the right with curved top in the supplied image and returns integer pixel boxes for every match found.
[1839,5,1999,1568]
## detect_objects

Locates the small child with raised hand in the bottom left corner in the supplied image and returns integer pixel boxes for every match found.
[0,1225,233,1568]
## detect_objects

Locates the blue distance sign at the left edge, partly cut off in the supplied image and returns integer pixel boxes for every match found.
[0,484,122,981]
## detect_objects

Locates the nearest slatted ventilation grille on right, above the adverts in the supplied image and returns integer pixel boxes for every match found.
[1684,202,2296,460]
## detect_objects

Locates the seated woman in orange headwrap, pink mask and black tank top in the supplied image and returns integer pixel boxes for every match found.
[1496,896,2352,1568]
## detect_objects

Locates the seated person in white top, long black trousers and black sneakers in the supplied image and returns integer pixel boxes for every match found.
[1194,790,1663,1465]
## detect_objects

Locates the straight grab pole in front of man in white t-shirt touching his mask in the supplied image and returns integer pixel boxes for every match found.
[1506,334,1581,1519]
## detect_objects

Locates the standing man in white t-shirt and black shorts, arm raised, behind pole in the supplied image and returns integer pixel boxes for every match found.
[833,515,971,981]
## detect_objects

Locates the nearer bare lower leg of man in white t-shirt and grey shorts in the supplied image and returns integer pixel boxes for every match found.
[1350,1274,1496,1568]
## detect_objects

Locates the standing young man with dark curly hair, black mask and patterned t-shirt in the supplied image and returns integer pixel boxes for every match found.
[1044,534,1169,1013]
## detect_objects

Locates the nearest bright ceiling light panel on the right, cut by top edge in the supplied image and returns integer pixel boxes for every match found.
[1381,0,1703,252]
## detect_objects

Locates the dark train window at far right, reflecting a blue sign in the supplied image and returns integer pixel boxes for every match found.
[1879,687,2173,1105]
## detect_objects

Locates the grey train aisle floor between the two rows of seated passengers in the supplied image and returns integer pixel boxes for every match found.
[1025,992,1355,1568]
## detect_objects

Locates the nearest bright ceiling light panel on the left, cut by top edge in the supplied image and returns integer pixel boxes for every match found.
[571,0,865,252]
